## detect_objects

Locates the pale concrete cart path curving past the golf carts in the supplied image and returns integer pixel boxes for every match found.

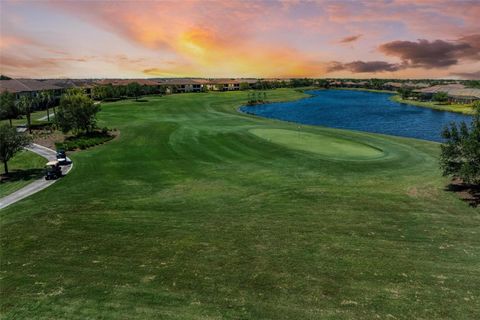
[0,143,73,209]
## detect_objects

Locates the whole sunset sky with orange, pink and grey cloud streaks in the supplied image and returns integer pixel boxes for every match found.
[0,0,480,78]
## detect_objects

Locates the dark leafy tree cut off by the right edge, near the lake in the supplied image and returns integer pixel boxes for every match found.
[440,102,480,184]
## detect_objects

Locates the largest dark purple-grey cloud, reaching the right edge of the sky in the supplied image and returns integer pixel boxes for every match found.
[379,35,480,69]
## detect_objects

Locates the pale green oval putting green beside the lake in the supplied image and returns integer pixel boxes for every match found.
[250,129,384,160]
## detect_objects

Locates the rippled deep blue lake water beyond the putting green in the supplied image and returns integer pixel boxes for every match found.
[240,90,471,142]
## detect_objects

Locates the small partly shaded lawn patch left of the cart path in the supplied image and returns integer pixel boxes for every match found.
[0,151,46,198]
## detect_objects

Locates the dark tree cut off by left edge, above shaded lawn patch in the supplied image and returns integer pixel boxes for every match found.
[0,124,31,174]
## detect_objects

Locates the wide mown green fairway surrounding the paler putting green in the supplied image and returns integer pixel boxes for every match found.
[0,89,480,319]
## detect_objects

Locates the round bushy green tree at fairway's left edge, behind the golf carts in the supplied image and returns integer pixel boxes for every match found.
[55,90,100,133]
